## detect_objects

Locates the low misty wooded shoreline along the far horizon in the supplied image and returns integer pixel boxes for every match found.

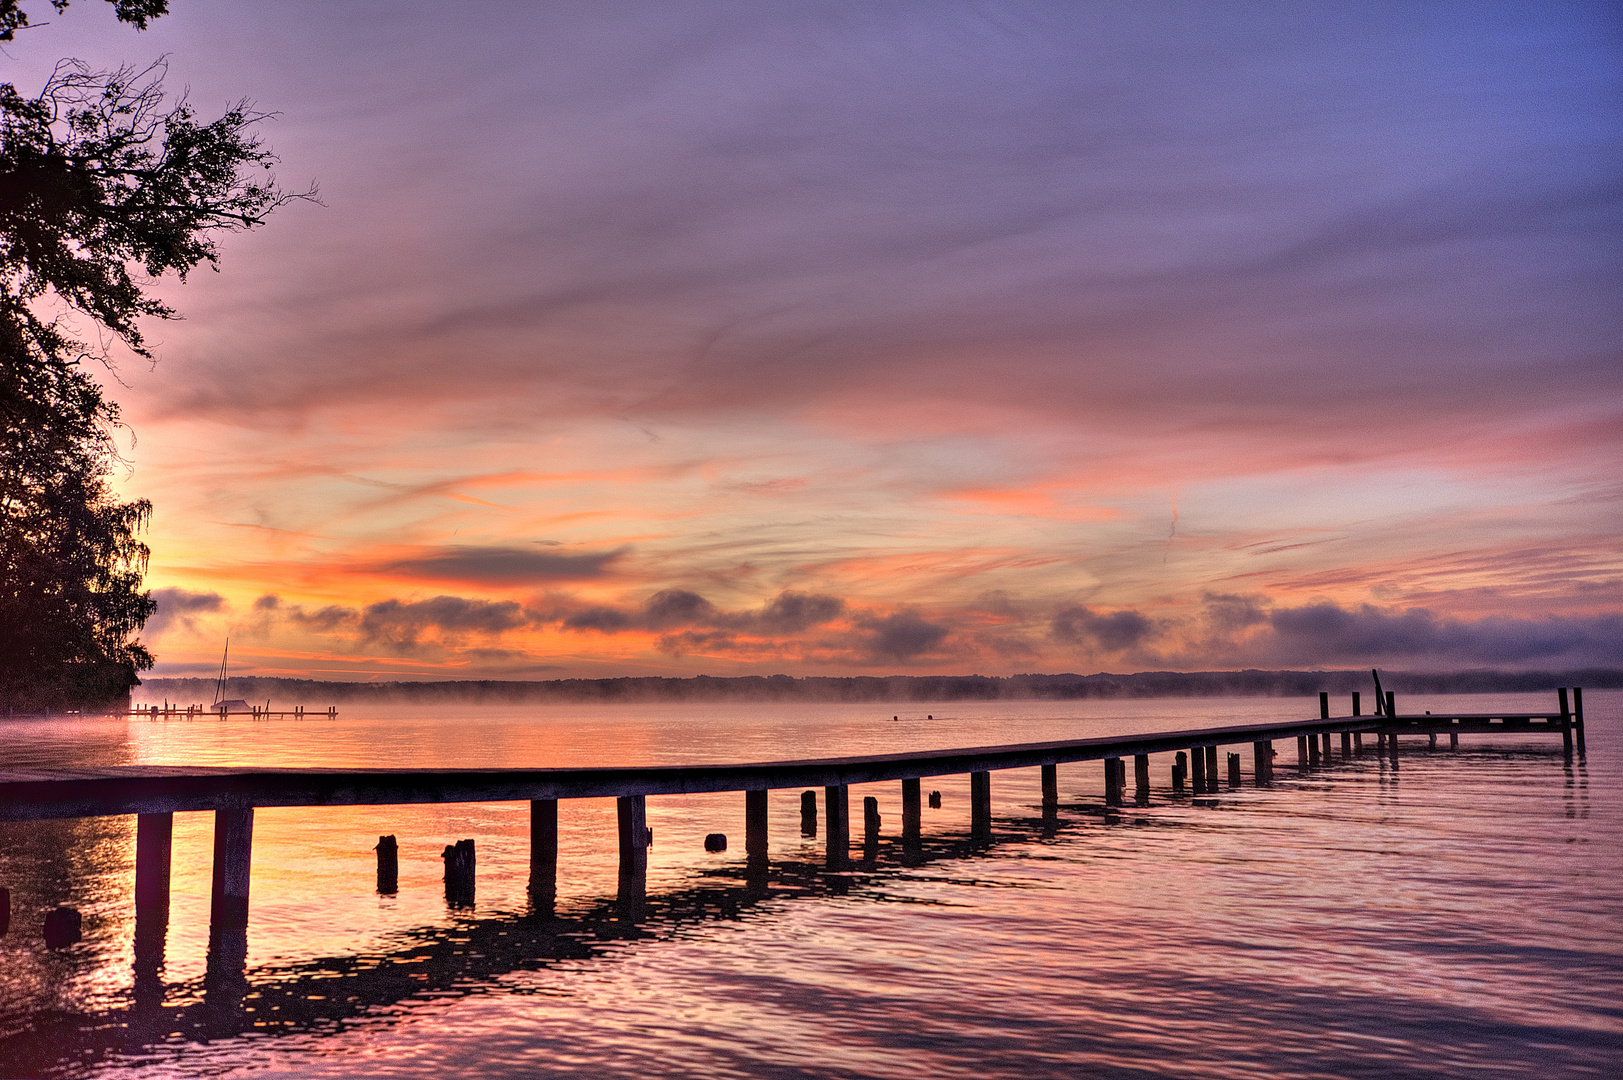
[117,667,1623,705]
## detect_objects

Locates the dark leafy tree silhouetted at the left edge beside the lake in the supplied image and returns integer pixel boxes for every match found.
[0,35,315,708]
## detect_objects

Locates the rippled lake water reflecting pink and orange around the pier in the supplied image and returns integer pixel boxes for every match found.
[0,692,1623,1078]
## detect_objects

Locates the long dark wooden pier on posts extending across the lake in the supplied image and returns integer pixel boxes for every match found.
[0,689,1584,965]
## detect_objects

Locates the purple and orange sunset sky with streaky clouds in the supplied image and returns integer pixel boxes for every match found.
[0,0,1623,679]
